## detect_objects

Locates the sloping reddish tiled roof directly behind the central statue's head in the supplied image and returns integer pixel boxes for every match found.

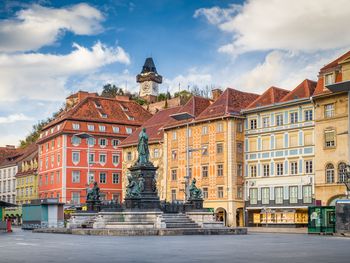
[120,106,181,147]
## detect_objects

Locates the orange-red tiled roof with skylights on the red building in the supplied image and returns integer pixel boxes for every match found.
[44,96,152,130]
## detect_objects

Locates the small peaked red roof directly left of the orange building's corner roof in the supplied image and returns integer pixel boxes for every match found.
[164,96,212,128]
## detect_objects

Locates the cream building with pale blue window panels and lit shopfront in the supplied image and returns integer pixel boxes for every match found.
[243,80,316,226]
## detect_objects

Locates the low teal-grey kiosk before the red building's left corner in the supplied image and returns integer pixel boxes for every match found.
[22,198,64,229]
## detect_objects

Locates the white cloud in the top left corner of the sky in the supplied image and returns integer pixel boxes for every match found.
[0,3,104,52]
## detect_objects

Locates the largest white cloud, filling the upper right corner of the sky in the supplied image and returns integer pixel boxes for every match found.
[195,0,350,55]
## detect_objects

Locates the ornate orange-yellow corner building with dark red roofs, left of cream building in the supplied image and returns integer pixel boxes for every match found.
[164,89,257,226]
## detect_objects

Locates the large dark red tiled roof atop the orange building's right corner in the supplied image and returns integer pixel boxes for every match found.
[196,88,259,120]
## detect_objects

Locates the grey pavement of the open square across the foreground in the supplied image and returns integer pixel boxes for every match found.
[0,229,350,263]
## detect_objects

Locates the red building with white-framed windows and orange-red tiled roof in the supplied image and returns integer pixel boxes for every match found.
[37,91,152,204]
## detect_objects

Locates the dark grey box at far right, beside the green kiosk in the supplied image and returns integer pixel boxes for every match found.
[335,200,350,235]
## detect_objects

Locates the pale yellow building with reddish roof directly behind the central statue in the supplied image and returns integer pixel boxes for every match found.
[119,107,181,200]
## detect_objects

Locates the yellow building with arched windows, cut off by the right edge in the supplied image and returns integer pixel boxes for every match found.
[313,51,350,205]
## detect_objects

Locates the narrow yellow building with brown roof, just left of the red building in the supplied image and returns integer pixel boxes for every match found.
[15,143,39,205]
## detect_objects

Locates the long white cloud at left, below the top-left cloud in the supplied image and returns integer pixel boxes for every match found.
[0,42,130,101]
